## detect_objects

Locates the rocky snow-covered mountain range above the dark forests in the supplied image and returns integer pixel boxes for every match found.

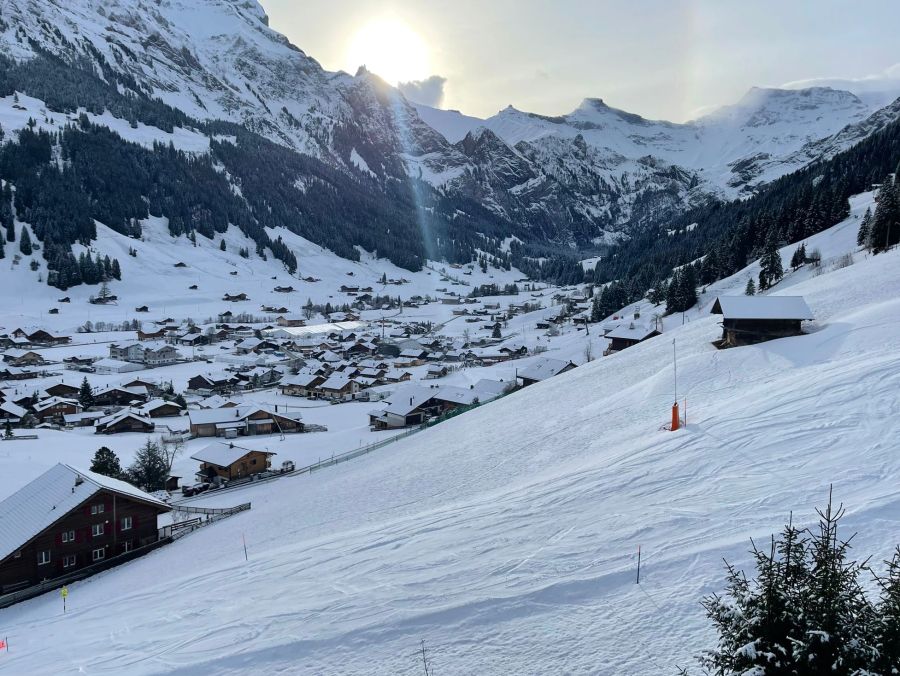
[0,0,897,247]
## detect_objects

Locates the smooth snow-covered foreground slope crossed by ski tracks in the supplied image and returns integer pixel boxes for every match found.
[0,199,900,675]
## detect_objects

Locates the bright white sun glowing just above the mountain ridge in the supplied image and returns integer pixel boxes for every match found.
[347,21,428,86]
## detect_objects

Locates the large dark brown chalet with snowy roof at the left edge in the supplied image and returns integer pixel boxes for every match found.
[0,464,171,594]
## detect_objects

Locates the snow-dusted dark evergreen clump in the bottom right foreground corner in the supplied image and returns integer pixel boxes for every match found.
[700,498,884,676]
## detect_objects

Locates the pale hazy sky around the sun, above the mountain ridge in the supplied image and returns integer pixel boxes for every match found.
[261,0,900,122]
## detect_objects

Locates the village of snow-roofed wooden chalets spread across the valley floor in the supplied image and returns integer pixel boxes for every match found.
[0,211,828,603]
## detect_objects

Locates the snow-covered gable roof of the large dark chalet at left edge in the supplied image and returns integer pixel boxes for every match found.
[0,463,171,560]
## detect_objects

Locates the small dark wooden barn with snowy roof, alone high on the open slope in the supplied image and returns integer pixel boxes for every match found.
[710,296,813,347]
